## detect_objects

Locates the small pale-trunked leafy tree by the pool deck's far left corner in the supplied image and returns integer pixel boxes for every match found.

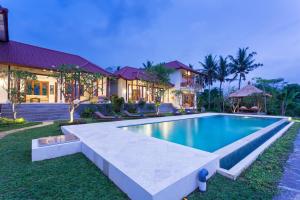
[53,65,101,123]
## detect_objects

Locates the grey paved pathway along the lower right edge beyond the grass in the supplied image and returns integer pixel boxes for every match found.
[274,130,300,200]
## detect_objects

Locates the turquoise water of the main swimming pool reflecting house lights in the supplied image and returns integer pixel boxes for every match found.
[120,115,279,152]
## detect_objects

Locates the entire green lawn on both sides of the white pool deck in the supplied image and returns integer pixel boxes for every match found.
[0,123,300,200]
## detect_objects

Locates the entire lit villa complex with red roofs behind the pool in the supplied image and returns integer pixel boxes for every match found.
[0,6,203,119]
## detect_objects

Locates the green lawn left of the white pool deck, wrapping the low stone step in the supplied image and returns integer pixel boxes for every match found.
[0,125,127,200]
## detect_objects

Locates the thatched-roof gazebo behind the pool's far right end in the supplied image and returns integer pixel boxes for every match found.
[229,82,271,112]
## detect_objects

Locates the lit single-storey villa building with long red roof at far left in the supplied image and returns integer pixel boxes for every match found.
[0,7,111,103]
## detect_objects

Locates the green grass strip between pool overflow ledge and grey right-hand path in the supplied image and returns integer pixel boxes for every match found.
[188,123,300,200]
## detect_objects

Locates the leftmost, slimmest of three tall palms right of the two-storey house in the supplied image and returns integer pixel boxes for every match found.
[216,56,230,112]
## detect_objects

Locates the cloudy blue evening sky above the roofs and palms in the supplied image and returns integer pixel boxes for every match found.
[0,0,300,83]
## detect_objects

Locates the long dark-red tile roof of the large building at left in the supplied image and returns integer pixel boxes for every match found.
[0,41,112,76]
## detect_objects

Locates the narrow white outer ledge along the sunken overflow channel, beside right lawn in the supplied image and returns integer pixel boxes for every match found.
[217,122,294,180]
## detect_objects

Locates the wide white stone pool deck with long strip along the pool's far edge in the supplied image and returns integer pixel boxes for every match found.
[62,114,219,199]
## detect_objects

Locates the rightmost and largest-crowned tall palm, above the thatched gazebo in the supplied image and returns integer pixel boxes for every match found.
[228,47,263,89]
